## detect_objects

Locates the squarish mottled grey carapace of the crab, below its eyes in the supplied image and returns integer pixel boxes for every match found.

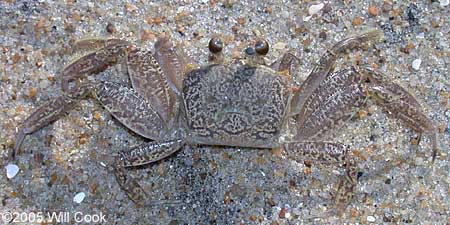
[183,64,291,147]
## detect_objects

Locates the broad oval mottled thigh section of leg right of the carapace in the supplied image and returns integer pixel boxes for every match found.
[296,69,367,140]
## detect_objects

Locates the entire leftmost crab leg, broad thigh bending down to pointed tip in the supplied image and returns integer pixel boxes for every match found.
[11,82,166,158]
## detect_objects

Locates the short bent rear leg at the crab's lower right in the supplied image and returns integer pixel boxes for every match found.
[284,141,358,209]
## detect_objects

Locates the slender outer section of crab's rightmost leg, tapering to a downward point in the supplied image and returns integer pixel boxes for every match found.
[362,68,438,161]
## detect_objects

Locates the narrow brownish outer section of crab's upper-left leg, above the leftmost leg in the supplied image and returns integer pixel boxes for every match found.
[62,41,131,91]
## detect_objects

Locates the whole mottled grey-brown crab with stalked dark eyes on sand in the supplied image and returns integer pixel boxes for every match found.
[12,31,437,211]
